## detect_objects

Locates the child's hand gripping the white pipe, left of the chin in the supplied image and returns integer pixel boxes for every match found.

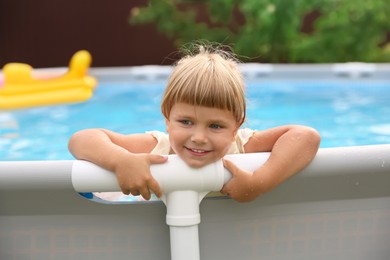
[115,154,168,200]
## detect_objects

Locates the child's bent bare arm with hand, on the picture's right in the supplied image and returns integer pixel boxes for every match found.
[221,125,321,202]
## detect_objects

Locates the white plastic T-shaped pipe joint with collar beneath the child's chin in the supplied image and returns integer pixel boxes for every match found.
[151,156,225,226]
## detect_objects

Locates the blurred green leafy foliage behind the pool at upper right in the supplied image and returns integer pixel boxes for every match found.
[130,0,390,63]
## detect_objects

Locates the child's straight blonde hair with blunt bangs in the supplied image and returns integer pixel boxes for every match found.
[161,45,246,125]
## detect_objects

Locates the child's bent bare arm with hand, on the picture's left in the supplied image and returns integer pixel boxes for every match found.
[68,129,167,199]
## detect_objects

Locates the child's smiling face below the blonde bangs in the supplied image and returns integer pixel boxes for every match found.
[166,103,239,168]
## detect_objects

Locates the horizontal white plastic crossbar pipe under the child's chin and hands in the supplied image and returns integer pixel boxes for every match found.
[72,153,268,193]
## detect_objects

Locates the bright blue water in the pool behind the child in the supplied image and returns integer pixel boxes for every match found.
[0,80,390,161]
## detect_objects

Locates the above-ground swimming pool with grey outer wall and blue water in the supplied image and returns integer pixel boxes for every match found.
[0,64,390,260]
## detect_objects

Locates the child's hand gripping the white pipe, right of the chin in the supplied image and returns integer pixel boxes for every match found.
[221,159,262,202]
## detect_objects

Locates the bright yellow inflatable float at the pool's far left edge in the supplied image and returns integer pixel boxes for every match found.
[0,50,97,109]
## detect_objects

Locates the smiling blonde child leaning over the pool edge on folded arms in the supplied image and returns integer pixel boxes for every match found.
[69,45,320,202]
